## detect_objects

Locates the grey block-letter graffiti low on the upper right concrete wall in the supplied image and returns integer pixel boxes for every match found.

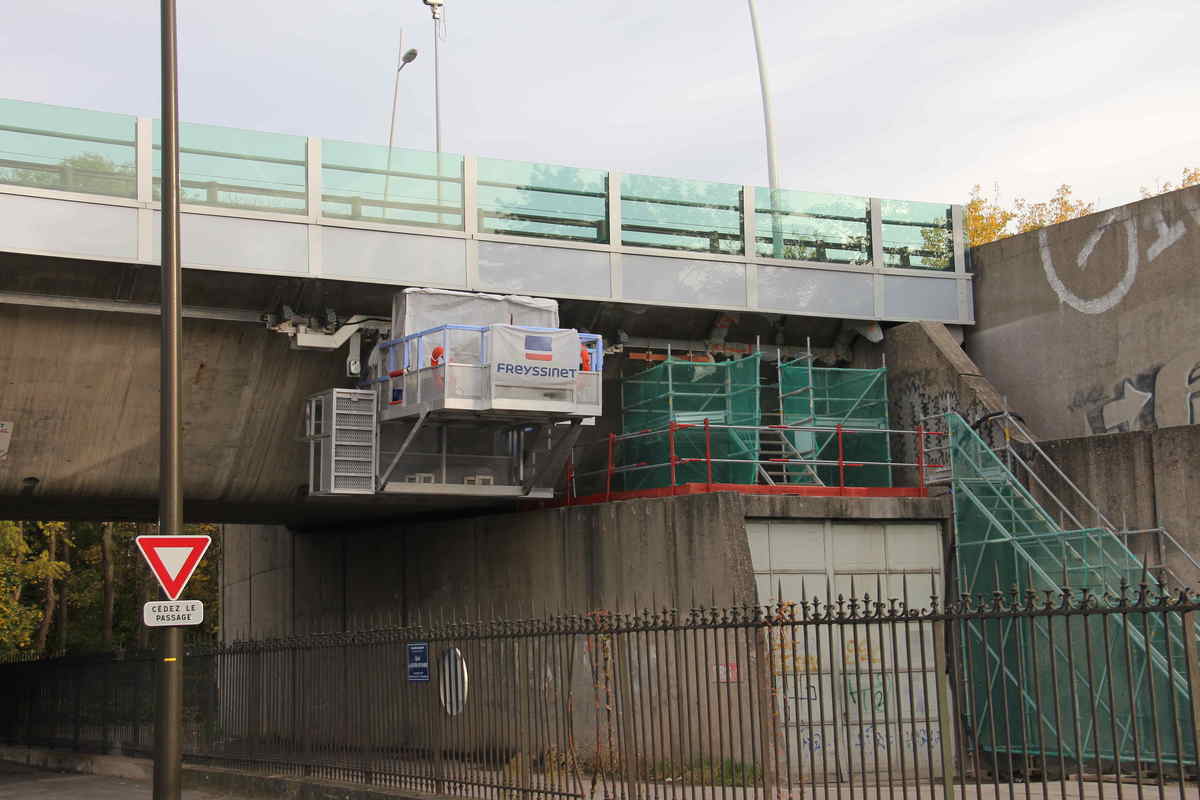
[1069,347,1200,433]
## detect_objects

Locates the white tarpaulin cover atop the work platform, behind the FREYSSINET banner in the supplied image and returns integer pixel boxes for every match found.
[391,289,558,338]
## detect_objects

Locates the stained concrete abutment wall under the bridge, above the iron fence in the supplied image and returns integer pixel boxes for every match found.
[222,493,947,640]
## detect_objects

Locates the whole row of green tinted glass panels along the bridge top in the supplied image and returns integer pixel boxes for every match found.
[0,100,965,271]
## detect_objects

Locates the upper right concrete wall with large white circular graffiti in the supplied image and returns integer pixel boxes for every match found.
[964,186,1200,438]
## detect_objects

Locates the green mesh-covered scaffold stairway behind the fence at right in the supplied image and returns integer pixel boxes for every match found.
[946,414,1196,771]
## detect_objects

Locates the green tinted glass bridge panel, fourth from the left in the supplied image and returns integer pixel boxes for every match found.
[476,158,608,242]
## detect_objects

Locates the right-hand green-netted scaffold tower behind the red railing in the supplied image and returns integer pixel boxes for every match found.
[779,347,892,487]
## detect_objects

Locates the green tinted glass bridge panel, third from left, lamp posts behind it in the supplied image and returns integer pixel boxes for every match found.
[320,139,463,230]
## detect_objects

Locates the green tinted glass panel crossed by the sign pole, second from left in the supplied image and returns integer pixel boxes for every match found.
[154,120,307,213]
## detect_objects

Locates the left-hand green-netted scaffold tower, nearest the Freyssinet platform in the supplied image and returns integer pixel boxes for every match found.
[618,354,762,491]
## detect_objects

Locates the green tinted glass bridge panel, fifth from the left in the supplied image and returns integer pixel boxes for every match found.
[620,175,743,253]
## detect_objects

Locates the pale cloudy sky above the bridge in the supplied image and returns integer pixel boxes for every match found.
[0,0,1200,209]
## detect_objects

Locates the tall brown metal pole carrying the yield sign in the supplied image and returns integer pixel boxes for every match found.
[154,0,184,800]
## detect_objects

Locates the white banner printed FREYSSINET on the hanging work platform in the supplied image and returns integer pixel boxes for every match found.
[491,325,580,387]
